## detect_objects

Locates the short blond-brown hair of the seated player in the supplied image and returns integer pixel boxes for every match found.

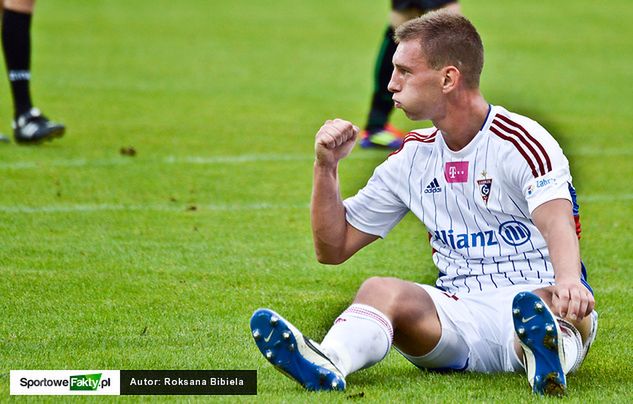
[395,10,484,88]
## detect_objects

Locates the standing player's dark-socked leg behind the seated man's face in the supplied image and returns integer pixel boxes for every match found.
[360,0,460,149]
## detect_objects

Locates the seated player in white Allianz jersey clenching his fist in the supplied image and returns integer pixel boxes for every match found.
[251,11,597,395]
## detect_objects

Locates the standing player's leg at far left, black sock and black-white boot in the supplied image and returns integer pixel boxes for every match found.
[2,0,65,144]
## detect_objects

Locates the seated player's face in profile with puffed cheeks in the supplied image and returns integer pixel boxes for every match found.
[388,40,444,121]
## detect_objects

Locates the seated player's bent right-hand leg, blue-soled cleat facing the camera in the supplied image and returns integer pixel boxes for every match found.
[512,287,597,395]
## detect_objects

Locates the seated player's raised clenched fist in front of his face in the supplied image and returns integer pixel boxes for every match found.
[314,119,360,166]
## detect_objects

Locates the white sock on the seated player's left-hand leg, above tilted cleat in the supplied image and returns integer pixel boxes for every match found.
[320,304,393,376]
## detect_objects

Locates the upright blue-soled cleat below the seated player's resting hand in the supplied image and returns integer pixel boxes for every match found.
[512,292,567,396]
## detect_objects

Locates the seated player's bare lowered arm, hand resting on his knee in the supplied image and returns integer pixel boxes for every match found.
[532,199,595,320]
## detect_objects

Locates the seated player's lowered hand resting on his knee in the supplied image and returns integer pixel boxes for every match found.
[552,280,595,320]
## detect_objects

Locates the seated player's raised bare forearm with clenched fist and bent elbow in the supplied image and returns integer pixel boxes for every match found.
[311,119,378,264]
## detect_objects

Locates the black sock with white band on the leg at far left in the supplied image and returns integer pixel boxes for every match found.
[2,9,33,118]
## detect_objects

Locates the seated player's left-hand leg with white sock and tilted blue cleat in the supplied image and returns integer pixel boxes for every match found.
[251,278,468,390]
